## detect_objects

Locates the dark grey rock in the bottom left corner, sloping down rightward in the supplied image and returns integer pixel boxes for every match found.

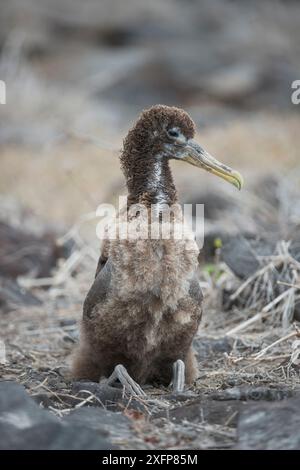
[0,382,114,450]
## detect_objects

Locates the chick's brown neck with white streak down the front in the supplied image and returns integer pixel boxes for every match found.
[127,155,177,210]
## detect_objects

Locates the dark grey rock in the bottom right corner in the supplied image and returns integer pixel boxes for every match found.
[237,398,300,450]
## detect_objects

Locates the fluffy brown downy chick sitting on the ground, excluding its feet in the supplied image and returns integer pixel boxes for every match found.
[73,105,242,385]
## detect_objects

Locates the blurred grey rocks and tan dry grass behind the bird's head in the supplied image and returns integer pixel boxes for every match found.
[0,0,300,226]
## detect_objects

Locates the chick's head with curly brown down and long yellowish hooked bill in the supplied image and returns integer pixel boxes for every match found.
[123,105,243,189]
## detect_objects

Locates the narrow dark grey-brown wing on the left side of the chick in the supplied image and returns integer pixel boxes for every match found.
[83,259,112,318]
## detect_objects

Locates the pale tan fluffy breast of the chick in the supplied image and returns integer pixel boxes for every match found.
[109,215,199,311]
